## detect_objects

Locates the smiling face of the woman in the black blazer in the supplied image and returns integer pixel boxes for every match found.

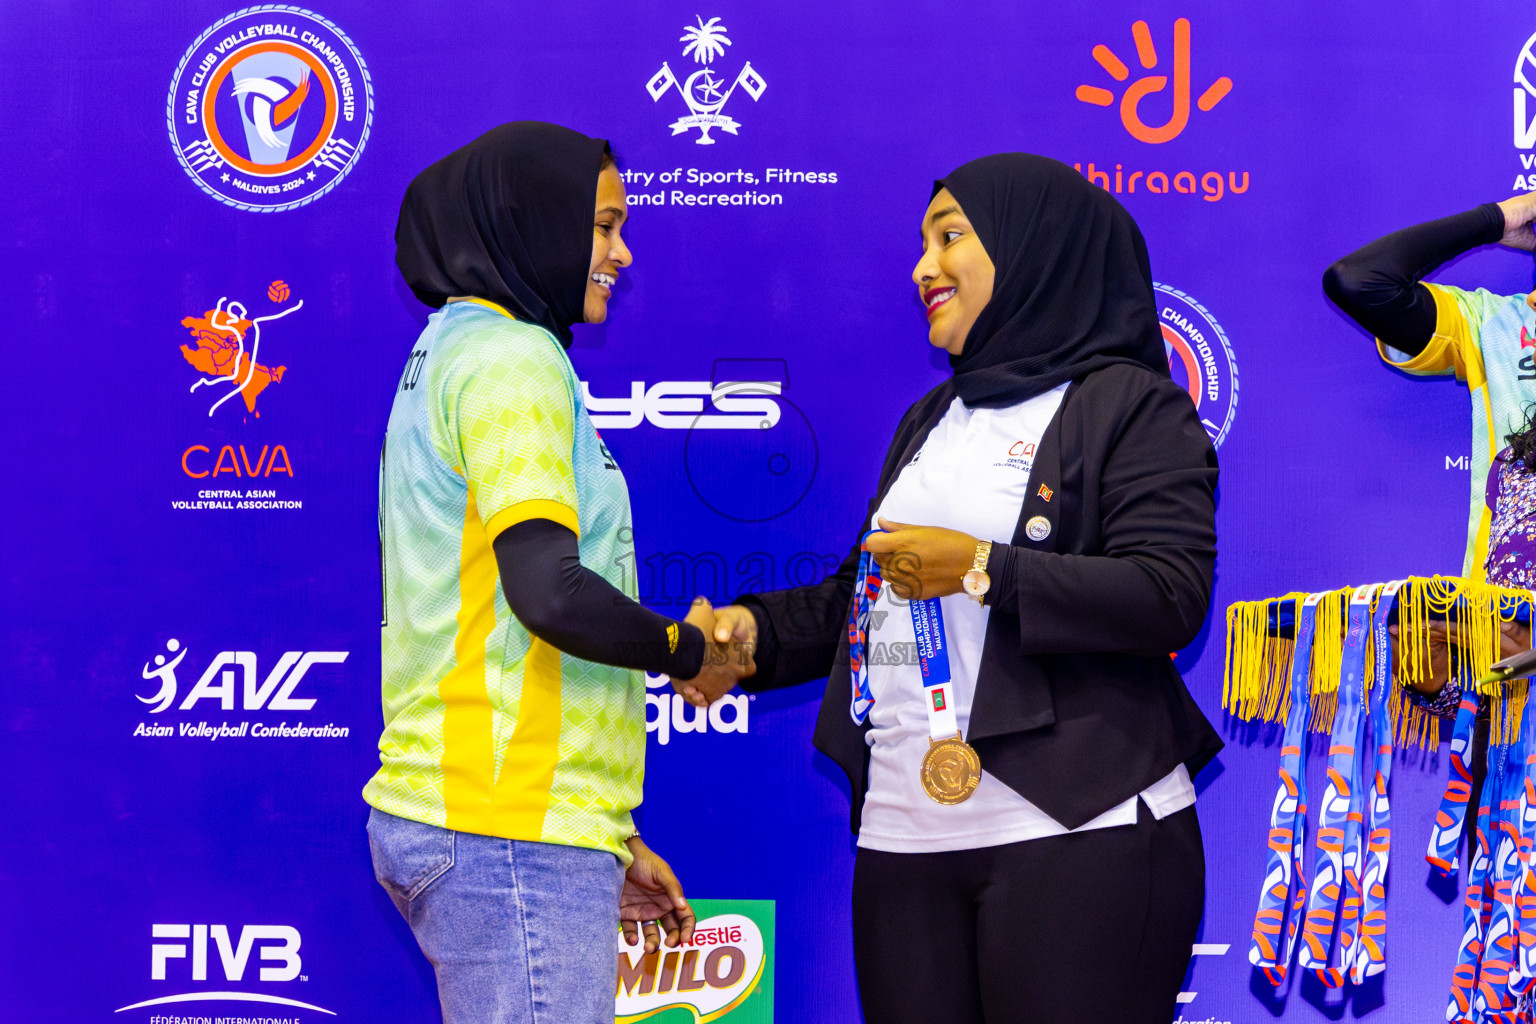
[912,189,994,356]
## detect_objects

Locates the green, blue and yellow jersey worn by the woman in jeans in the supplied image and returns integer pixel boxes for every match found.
[362,301,645,864]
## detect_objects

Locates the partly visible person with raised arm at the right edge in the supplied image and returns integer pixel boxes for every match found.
[1322,193,1536,579]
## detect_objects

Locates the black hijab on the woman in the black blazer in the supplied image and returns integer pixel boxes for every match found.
[934,154,1167,407]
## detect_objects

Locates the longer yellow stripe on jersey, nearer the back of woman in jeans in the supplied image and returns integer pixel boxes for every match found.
[438,488,496,835]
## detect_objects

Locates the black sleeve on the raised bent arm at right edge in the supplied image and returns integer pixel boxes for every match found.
[1322,203,1504,356]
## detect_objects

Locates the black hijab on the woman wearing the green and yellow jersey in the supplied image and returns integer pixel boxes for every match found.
[395,121,608,347]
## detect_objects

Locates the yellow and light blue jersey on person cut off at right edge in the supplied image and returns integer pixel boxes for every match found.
[1376,282,1536,579]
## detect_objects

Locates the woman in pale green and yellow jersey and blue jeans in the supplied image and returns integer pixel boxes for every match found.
[364,121,753,1024]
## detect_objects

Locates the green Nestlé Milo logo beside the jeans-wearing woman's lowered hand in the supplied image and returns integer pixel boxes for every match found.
[614,900,774,1024]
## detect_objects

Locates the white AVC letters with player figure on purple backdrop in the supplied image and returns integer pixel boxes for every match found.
[138,637,347,714]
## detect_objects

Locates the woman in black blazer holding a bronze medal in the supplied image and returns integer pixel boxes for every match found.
[682,154,1221,1024]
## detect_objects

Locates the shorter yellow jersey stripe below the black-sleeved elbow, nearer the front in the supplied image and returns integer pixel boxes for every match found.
[495,637,561,840]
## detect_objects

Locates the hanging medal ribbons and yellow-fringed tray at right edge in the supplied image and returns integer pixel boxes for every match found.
[1223,577,1536,1024]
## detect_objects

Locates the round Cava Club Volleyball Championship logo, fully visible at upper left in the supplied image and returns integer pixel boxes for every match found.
[166,5,373,213]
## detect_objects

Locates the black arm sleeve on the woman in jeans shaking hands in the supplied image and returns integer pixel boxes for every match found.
[492,519,705,679]
